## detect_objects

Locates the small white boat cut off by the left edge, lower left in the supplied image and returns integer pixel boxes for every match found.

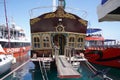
[0,45,14,75]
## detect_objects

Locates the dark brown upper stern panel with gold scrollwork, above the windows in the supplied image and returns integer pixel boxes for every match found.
[30,7,87,33]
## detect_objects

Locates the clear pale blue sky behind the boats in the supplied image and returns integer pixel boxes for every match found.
[0,0,120,40]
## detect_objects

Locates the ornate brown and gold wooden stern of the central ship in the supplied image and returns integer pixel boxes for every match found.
[30,6,87,58]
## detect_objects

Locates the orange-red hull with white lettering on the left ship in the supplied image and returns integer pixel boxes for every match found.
[4,46,31,58]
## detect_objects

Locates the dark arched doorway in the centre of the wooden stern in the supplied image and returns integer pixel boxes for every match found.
[53,34,66,55]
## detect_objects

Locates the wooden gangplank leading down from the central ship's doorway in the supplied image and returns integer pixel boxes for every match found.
[56,55,81,78]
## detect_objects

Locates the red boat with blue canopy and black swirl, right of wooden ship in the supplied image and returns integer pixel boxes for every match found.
[85,28,120,68]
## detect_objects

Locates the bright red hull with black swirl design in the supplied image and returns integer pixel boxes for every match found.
[85,48,120,68]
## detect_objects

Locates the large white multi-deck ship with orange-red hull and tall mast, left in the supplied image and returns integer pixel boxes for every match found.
[0,0,30,58]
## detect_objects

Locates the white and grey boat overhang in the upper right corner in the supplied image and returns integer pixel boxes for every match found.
[97,0,120,22]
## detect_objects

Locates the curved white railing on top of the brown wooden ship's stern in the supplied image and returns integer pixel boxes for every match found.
[29,6,88,19]
